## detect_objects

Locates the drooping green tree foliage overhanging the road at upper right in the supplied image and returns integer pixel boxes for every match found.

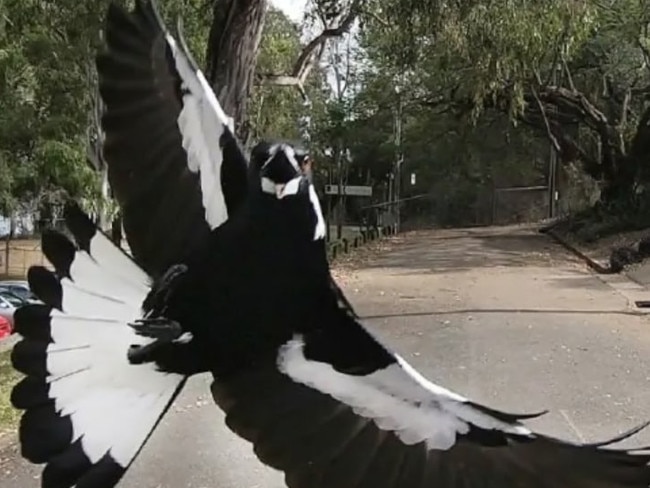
[346,0,650,225]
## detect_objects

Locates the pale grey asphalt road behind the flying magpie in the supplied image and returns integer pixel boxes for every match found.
[0,228,650,488]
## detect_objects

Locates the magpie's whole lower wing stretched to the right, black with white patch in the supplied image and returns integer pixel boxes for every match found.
[212,300,650,488]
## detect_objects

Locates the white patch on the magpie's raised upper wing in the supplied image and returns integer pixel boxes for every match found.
[165,34,234,229]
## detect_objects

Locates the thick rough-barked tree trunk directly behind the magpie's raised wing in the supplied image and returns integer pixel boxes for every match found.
[206,0,268,142]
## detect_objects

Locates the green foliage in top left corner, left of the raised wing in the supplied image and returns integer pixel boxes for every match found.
[0,0,107,209]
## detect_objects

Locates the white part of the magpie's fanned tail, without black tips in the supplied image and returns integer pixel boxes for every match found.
[46,233,183,467]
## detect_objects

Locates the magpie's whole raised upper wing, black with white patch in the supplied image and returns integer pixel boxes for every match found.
[97,0,248,278]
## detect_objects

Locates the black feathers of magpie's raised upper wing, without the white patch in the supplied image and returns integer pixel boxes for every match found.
[97,0,247,278]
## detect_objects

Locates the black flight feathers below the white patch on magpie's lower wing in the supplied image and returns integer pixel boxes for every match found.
[212,309,650,488]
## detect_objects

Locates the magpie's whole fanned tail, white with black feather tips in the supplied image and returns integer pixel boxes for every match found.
[11,202,185,488]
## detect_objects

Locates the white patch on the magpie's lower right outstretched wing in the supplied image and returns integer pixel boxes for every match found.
[278,335,531,450]
